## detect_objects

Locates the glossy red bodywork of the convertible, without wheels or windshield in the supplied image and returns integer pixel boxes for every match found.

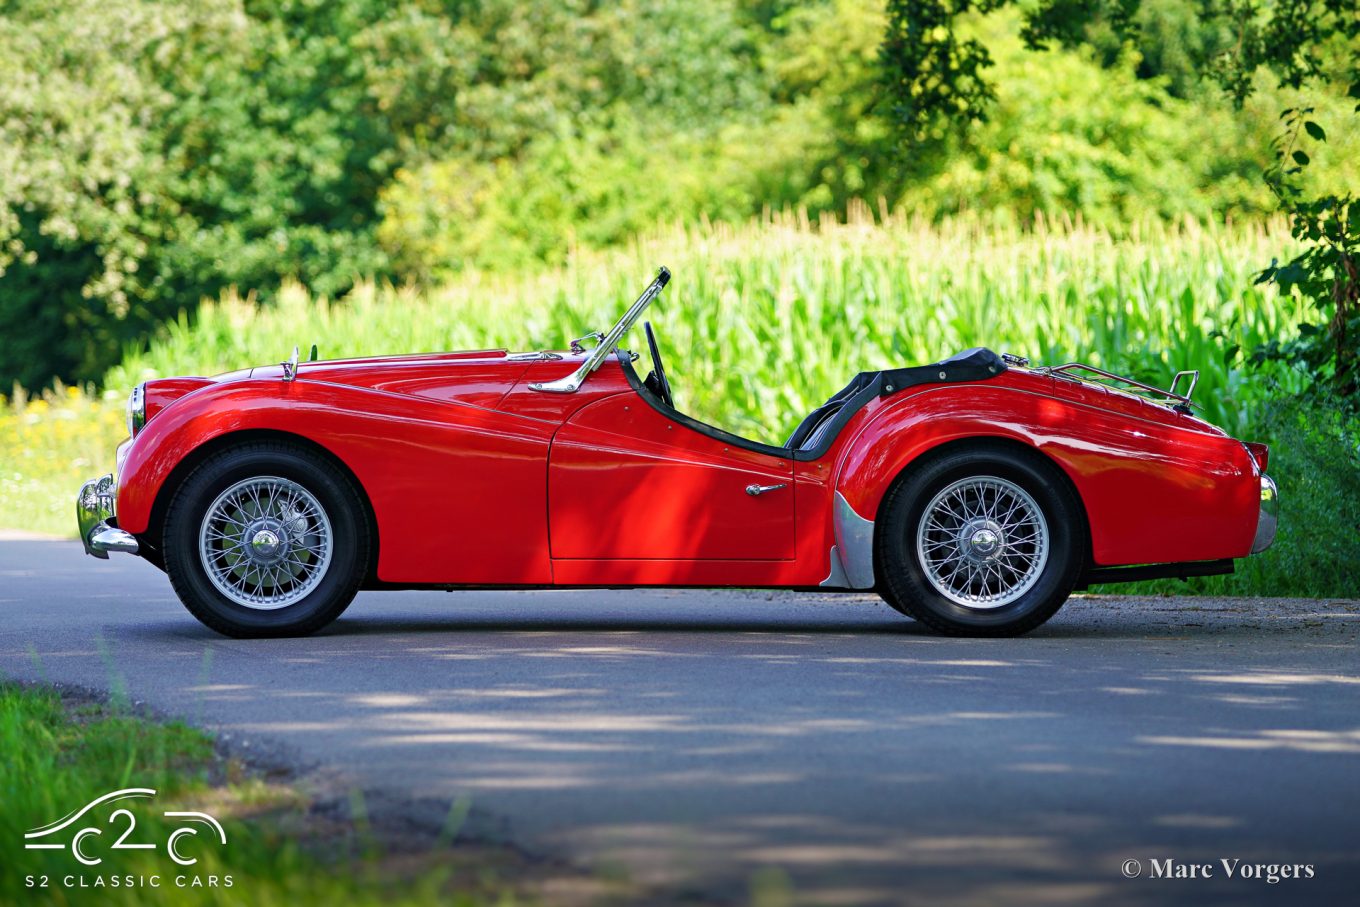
[86,269,1274,639]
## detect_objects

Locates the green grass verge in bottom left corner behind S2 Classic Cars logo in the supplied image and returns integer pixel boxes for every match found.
[0,684,524,907]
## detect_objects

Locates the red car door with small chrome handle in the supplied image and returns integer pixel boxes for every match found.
[548,392,794,562]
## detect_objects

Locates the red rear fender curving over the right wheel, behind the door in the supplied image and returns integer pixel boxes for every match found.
[835,383,1259,579]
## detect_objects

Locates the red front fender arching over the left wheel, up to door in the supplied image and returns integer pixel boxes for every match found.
[118,379,554,585]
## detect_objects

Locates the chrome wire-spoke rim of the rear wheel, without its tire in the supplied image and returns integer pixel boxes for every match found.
[915,476,1050,609]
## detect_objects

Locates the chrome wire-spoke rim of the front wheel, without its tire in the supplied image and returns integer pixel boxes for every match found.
[199,476,335,611]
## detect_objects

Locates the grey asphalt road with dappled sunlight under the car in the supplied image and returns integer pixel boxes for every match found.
[0,541,1360,904]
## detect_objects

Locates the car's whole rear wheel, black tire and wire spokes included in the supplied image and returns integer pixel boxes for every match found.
[876,443,1087,636]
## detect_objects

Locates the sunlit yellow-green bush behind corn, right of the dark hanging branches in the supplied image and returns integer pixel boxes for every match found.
[903,16,1273,221]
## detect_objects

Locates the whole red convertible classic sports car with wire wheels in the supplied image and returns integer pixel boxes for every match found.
[78,268,1277,636]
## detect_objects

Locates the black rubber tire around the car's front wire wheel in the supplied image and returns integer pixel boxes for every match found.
[162,442,371,638]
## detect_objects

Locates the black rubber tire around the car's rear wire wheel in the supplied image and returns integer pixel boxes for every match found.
[874,442,1089,636]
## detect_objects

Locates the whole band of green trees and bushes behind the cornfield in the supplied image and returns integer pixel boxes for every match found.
[0,0,1360,399]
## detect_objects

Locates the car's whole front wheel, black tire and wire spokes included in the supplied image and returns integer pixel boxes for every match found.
[163,442,370,636]
